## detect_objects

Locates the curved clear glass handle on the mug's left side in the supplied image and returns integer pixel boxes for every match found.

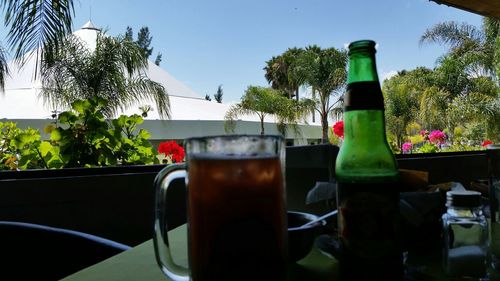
[153,164,189,281]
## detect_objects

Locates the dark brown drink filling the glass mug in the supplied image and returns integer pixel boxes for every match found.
[188,155,287,281]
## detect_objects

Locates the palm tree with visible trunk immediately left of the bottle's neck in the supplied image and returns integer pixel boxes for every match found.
[294,46,347,142]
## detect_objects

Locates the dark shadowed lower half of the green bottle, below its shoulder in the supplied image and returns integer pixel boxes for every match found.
[337,182,404,281]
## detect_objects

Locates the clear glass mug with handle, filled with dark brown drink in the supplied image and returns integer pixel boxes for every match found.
[153,135,288,281]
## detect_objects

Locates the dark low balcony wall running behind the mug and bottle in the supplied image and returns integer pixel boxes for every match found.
[0,145,490,245]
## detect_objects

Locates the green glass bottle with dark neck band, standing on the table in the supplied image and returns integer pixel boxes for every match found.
[335,40,403,280]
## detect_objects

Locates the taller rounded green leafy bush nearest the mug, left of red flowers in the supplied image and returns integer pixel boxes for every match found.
[50,98,158,167]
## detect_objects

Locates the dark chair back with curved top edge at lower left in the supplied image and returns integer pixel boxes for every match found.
[0,221,130,280]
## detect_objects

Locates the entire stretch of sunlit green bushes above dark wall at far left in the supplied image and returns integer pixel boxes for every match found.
[0,98,159,170]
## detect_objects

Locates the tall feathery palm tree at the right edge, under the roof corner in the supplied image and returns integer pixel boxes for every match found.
[420,17,500,139]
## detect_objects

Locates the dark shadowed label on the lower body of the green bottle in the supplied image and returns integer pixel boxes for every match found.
[337,183,401,259]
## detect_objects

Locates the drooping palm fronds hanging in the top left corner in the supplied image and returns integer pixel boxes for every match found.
[0,0,74,88]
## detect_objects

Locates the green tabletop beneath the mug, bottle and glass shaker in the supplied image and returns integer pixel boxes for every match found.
[62,225,500,281]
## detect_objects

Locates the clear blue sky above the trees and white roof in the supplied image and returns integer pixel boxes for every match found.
[34,0,488,102]
